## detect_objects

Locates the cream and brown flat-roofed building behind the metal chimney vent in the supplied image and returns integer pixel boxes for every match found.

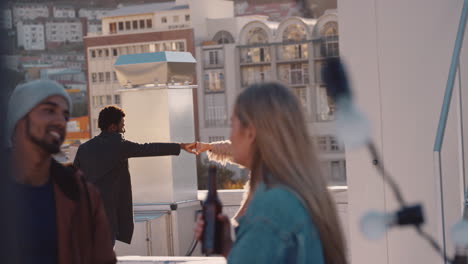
[84,0,233,136]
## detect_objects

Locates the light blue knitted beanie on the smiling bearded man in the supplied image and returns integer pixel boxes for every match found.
[5,80,72,147]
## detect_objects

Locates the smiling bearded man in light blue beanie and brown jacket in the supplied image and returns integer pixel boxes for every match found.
[5,80,116,264]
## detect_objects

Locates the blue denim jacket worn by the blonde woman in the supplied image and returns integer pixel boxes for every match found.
[228,184,325,264]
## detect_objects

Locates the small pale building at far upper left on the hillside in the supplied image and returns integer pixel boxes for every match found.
[16,20,45,50]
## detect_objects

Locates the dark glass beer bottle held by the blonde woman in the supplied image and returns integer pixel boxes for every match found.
[202,165,223,256]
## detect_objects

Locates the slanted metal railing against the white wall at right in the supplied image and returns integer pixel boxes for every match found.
[434,0,468,262]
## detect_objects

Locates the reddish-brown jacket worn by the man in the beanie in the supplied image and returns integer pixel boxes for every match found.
[2,158,117,264]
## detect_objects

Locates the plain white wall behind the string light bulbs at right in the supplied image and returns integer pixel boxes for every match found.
[338,0,468,264]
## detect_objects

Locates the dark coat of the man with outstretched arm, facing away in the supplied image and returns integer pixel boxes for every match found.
[74,132,180,244]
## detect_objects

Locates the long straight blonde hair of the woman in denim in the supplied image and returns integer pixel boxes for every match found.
[234,83,347,264]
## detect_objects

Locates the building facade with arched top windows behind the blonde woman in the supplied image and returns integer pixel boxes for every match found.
[197,11,346,185]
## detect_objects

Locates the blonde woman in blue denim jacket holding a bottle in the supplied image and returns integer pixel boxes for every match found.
[195,83,347,264]
